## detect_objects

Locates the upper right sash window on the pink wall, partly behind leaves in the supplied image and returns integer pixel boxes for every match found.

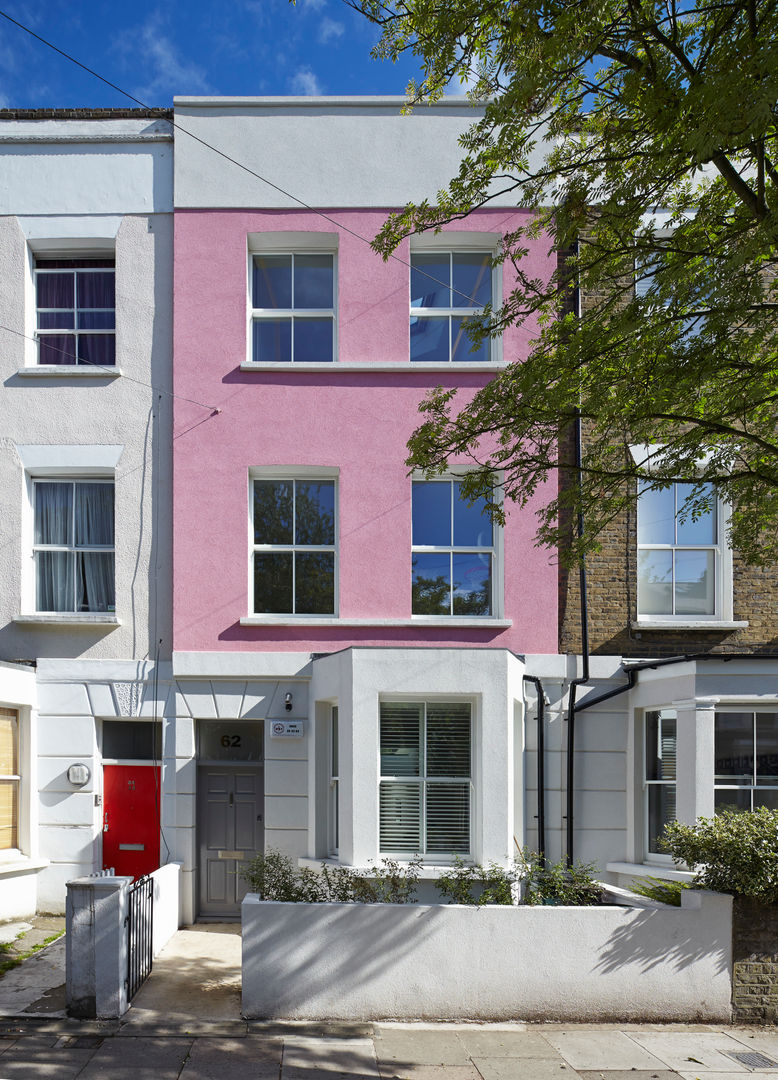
[411,251,493,364]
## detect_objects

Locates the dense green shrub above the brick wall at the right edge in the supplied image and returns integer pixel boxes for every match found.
[661,807,778,904]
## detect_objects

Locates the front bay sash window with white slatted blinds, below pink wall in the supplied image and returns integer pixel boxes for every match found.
[379,701,472,862]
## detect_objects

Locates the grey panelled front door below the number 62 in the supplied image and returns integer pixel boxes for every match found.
[198,765,265,919]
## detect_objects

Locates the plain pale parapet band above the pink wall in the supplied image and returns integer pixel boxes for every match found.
[175,97,551,208]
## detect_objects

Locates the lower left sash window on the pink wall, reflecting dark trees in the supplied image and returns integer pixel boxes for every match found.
[253,478,335,616]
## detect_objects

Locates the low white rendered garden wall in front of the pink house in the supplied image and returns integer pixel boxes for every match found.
[242,892,732,1021]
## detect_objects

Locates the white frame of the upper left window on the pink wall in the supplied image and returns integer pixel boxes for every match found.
[246,232,338,370]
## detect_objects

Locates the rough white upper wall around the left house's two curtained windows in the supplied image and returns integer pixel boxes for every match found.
[0,203,173,659]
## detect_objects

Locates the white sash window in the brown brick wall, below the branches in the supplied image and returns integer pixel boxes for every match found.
[638,483,723,622]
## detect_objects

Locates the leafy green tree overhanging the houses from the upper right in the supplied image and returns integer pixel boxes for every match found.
[349,0,778,562]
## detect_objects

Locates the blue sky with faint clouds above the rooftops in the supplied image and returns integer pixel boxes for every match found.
[0,0,425,108]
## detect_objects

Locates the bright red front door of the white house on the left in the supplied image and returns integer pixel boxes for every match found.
[103,765,160,877]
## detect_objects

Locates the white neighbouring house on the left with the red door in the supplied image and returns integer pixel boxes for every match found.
[0,109,173,918]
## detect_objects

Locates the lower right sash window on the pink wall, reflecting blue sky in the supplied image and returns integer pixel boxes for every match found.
[412,480,496,616]
